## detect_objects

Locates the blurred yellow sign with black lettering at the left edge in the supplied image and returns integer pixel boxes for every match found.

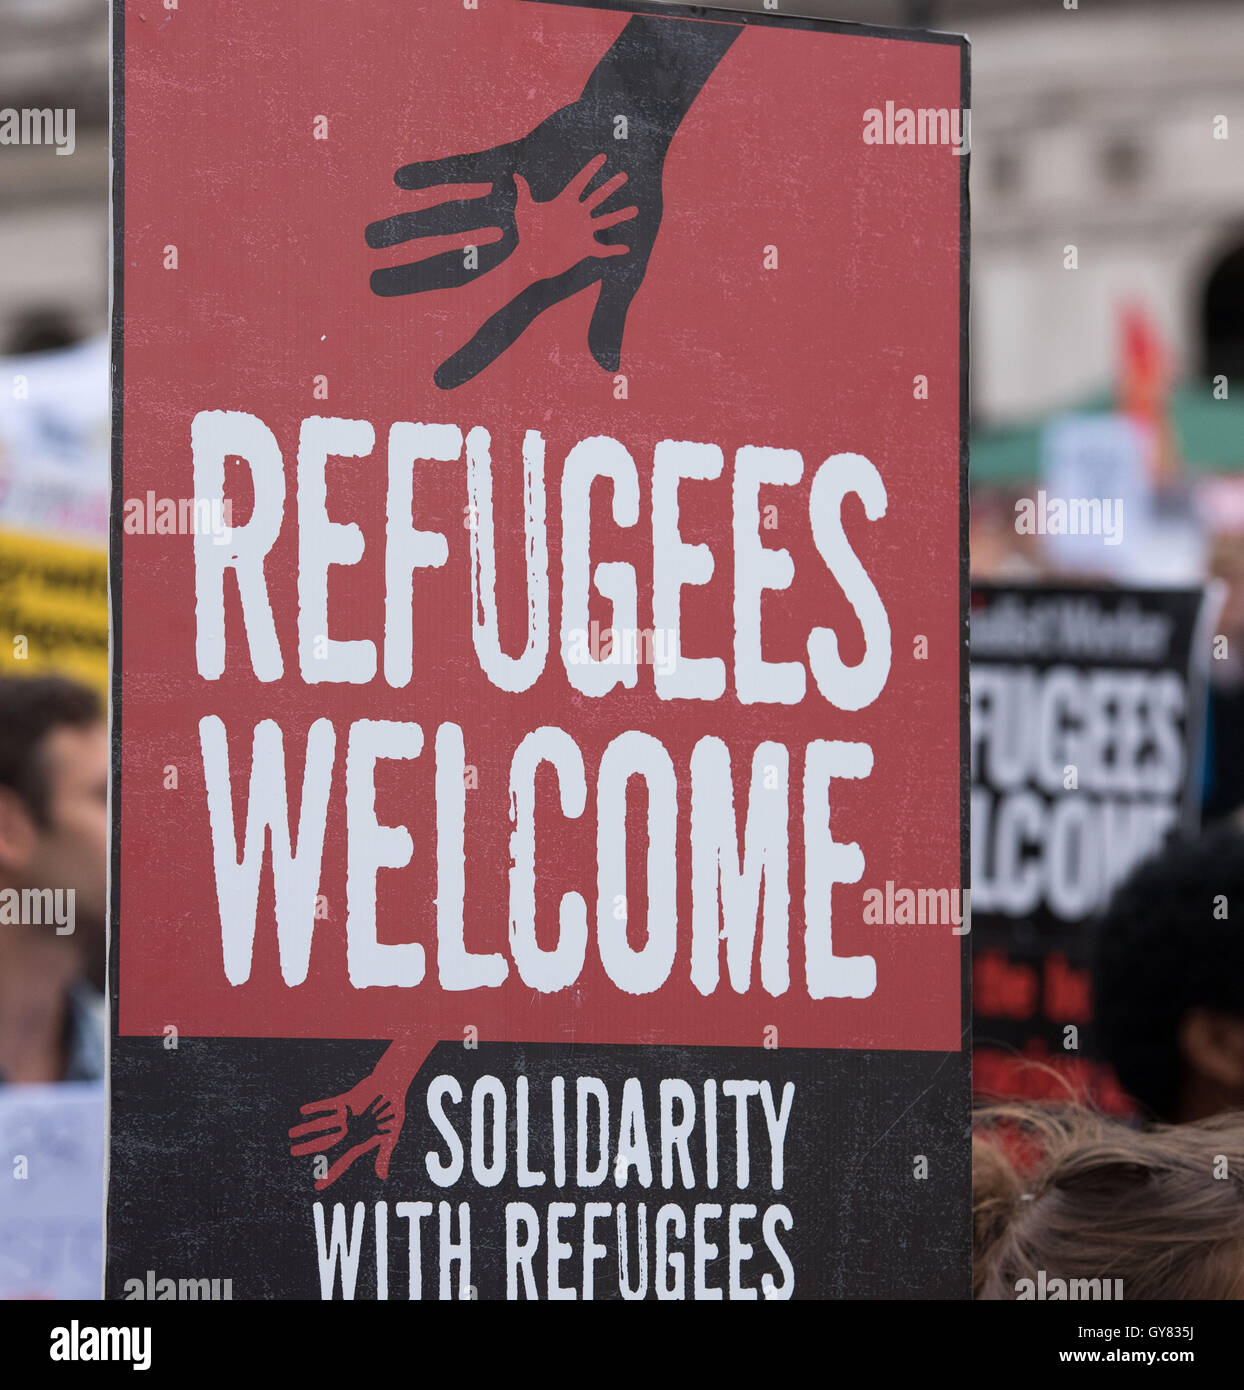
[0,528,108,699]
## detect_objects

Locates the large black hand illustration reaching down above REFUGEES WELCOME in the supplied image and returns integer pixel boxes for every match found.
[367,15,742,389]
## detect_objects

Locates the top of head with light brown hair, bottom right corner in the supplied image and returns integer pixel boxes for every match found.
[972,1105,1244,1300]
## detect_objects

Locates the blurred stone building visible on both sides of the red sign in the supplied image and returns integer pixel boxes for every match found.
[0,0,1244,430]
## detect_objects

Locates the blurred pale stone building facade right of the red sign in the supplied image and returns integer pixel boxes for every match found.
[972,3,1244,425]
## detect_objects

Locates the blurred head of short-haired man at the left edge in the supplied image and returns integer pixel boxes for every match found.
[0,676,108,977]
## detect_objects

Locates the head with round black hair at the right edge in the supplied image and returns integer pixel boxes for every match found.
[1092,821,1244,1120]
